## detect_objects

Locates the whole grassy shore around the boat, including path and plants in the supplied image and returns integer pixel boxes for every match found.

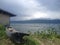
[0,25,60,45]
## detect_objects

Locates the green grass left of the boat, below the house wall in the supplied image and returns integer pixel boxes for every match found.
[0,24,14,45]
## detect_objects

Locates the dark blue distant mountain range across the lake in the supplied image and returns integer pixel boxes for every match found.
[11,19,60,23]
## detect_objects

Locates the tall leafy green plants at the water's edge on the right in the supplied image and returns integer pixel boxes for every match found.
[34,28,60,40]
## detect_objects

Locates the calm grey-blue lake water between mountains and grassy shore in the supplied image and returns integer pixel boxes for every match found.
[11,23,60,33]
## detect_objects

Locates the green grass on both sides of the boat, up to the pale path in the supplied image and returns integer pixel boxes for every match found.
[0,25,38,45]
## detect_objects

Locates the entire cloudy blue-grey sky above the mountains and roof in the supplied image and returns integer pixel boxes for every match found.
[0,0,60,21]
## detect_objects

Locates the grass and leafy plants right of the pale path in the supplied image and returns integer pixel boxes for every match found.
[32,28,60,45]
